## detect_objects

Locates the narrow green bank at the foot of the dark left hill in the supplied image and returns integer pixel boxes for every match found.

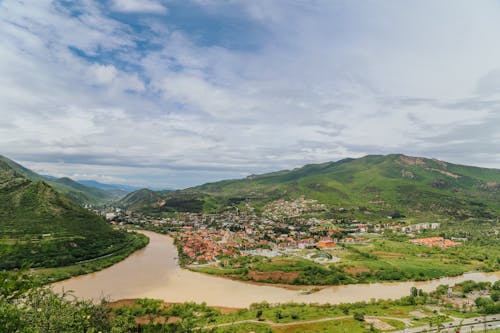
[33,233,149,284]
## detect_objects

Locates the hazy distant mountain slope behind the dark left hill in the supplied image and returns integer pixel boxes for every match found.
[0,155,122,204]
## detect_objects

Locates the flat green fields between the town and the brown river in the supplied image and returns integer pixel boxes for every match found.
[189,228,500,285]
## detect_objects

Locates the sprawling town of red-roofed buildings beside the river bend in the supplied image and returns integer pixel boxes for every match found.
[94,197,461,265]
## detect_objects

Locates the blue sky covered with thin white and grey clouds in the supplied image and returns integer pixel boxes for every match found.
[0,0,500,188]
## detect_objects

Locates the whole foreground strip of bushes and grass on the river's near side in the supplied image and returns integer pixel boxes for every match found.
[0,271,500,333]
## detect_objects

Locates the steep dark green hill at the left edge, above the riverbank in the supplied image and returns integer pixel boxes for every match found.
[0,160,140,269]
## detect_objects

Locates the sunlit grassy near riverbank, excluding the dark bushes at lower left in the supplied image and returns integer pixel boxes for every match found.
[102,282,500,333]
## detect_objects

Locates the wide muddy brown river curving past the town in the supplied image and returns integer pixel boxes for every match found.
[53,231,500,308]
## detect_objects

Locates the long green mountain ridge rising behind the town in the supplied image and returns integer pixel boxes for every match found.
[119,154,500,220]
